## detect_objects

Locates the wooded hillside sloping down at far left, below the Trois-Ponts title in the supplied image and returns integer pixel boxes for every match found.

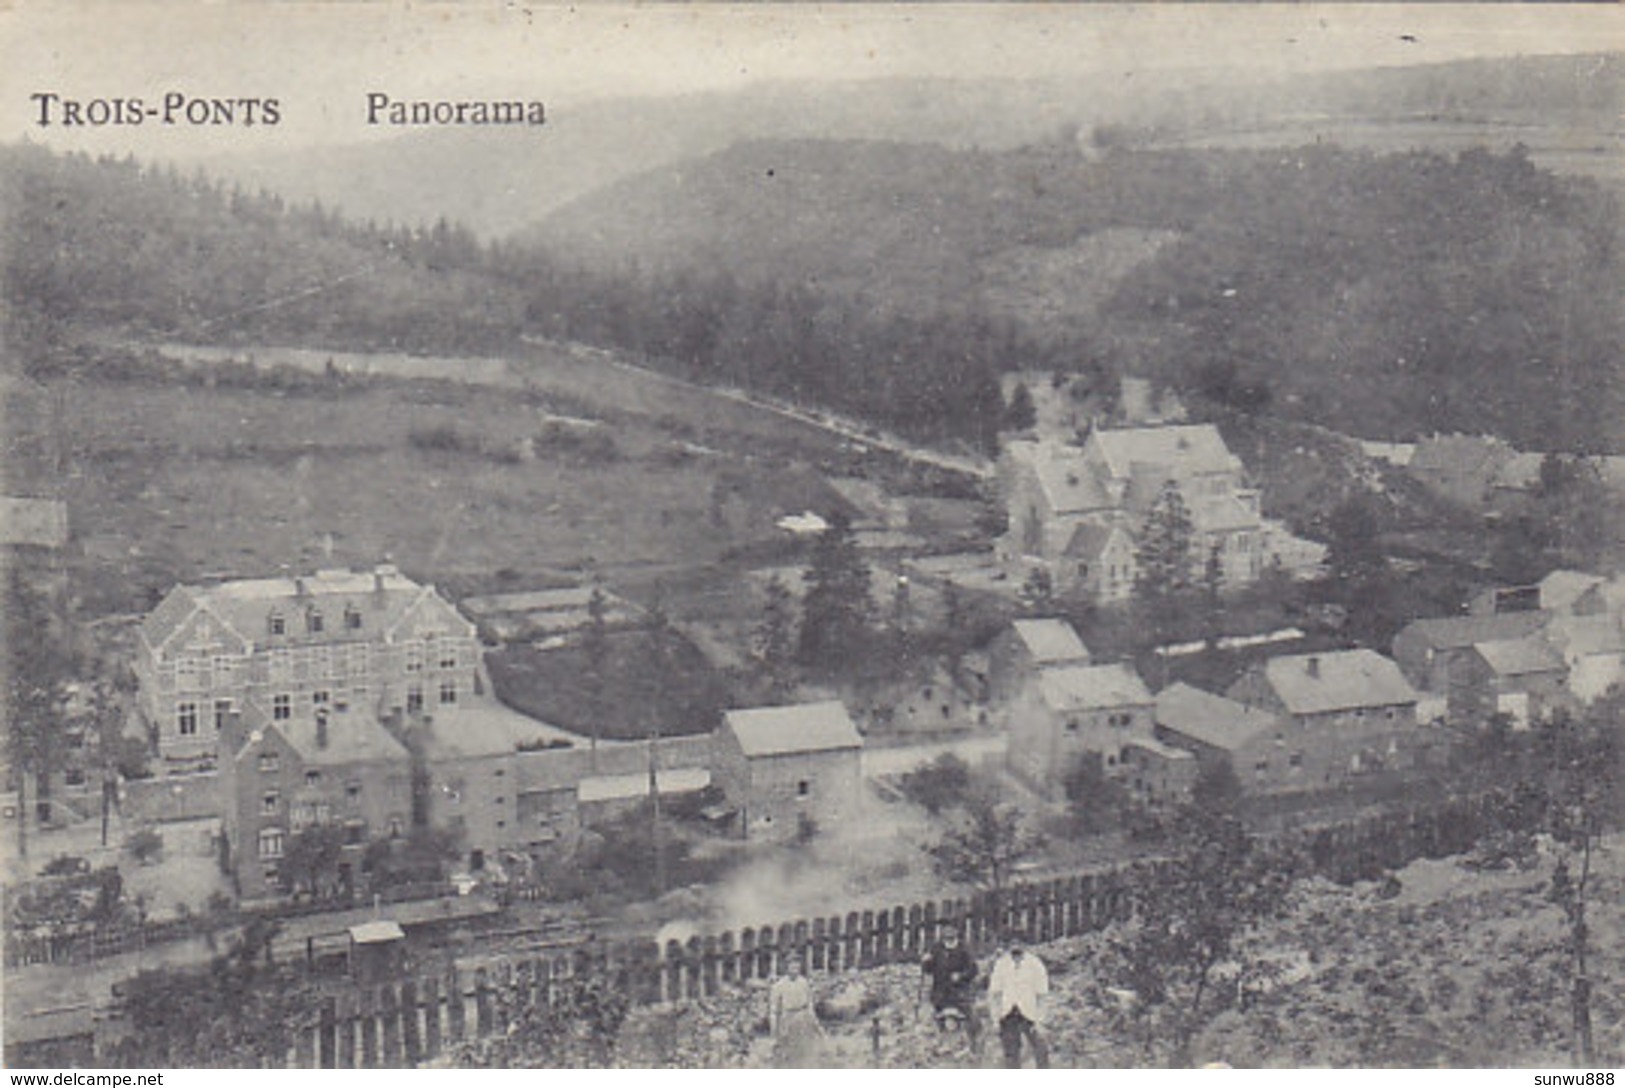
[0,146,520,351]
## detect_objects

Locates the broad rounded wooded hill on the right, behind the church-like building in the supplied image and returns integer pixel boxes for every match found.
[527,141,1625,448]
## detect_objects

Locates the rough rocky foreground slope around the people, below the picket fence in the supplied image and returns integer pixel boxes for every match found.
[616,840,1625,1069]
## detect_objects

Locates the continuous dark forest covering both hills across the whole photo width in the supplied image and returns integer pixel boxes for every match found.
[9,140,1625,450]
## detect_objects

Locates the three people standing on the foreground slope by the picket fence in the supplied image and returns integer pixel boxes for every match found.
[769,924,1050,1069]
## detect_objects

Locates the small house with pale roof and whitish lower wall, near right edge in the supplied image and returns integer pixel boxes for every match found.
[1448,633,1568,729]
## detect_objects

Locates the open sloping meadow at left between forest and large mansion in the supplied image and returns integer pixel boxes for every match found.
[3,349,877,612]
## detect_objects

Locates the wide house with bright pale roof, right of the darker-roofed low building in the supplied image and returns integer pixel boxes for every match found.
[1225,650,1445,789]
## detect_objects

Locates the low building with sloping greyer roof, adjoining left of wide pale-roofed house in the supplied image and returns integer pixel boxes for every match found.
[1155,682,1293,792]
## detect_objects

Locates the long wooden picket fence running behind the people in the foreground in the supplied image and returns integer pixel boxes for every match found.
[273,797,1500,1069]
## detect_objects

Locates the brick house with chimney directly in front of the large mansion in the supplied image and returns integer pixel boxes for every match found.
[219,698,413,900]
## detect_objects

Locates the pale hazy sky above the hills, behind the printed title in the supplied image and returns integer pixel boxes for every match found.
[0,0,1625,156]
